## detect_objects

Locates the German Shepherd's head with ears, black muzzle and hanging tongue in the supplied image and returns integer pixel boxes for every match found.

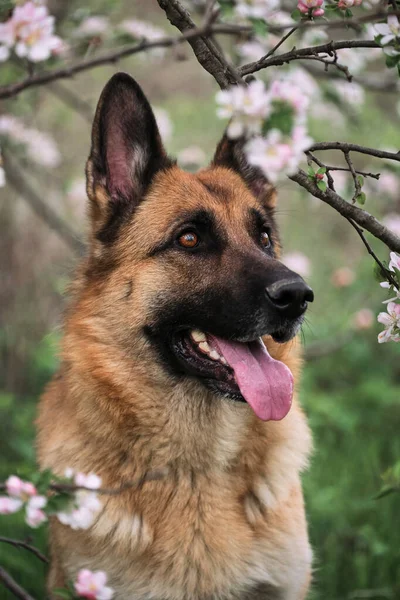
[81,74,313,419]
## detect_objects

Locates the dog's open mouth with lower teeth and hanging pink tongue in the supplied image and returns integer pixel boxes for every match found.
[172,329,293,421]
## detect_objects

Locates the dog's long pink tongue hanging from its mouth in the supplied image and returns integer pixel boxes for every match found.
[210,336,293,421]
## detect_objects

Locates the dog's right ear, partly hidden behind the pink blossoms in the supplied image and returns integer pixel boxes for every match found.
[211,133,276,208]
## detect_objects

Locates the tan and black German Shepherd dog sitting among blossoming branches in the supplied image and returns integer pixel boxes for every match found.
[38,73,313,600]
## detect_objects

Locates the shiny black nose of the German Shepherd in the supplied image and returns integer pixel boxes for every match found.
[265,277,314,319]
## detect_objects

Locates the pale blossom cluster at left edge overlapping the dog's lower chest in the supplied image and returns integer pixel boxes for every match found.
[0,469,101,529]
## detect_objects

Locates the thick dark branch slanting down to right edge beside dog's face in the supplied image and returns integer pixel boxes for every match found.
[289,169,400,252]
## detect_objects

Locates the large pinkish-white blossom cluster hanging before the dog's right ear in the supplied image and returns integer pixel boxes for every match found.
[216,79,312,183]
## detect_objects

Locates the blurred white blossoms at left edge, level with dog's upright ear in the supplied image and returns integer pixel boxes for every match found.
[0,115,61,167]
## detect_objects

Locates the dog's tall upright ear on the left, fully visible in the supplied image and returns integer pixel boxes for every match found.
[86,73,172,237]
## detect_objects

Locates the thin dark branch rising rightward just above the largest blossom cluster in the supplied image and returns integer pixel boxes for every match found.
[238,40,380,77]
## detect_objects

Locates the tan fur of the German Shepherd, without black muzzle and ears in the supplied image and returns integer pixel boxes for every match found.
[38,167,311,600]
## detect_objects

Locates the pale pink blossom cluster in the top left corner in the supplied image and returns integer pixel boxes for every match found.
[0,0,65,62]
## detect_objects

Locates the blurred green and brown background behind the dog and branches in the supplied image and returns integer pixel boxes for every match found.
[0,0,400,600]
